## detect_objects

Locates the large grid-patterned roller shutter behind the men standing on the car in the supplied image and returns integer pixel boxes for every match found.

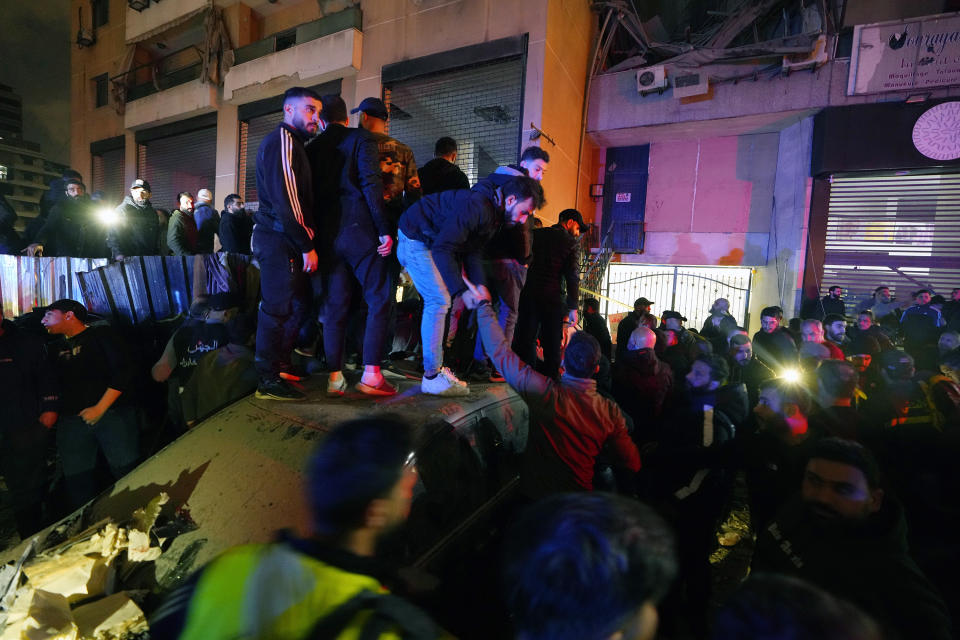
[385,57,523,184]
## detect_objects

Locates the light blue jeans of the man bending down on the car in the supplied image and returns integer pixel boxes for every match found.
[397,231,450,376]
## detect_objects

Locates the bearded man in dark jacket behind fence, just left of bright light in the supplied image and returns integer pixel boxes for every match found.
[28,178,107,258]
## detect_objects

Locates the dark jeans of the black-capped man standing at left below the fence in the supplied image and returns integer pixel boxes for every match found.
[57,406,140,507]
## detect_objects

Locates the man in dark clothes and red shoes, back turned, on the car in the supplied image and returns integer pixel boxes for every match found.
[307,95,397,396]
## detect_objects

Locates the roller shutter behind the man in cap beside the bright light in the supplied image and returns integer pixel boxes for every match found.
[137,126,218,210]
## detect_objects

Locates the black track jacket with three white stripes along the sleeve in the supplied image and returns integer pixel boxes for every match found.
[254,123,315,253]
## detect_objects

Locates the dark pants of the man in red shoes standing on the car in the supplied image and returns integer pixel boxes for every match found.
[323,225,394,371]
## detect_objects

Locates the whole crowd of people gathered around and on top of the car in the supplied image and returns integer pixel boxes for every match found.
[0,88,960,639]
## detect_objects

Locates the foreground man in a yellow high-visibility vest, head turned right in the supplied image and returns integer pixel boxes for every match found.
[160,418,439,640]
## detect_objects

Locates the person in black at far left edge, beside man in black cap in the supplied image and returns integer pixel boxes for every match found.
[0,316,59,540]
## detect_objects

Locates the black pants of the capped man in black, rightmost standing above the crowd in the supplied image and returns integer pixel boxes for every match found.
[513,292,567,378]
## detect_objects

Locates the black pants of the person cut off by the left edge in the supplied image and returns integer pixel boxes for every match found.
[0,422,52,540]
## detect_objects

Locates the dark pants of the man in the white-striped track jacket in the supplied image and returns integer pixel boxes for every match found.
[253,228,309,380]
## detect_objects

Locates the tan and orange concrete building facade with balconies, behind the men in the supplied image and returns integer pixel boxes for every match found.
[71,0,595,220]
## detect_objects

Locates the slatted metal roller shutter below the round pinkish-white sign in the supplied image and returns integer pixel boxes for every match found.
[821,174,960,313]
